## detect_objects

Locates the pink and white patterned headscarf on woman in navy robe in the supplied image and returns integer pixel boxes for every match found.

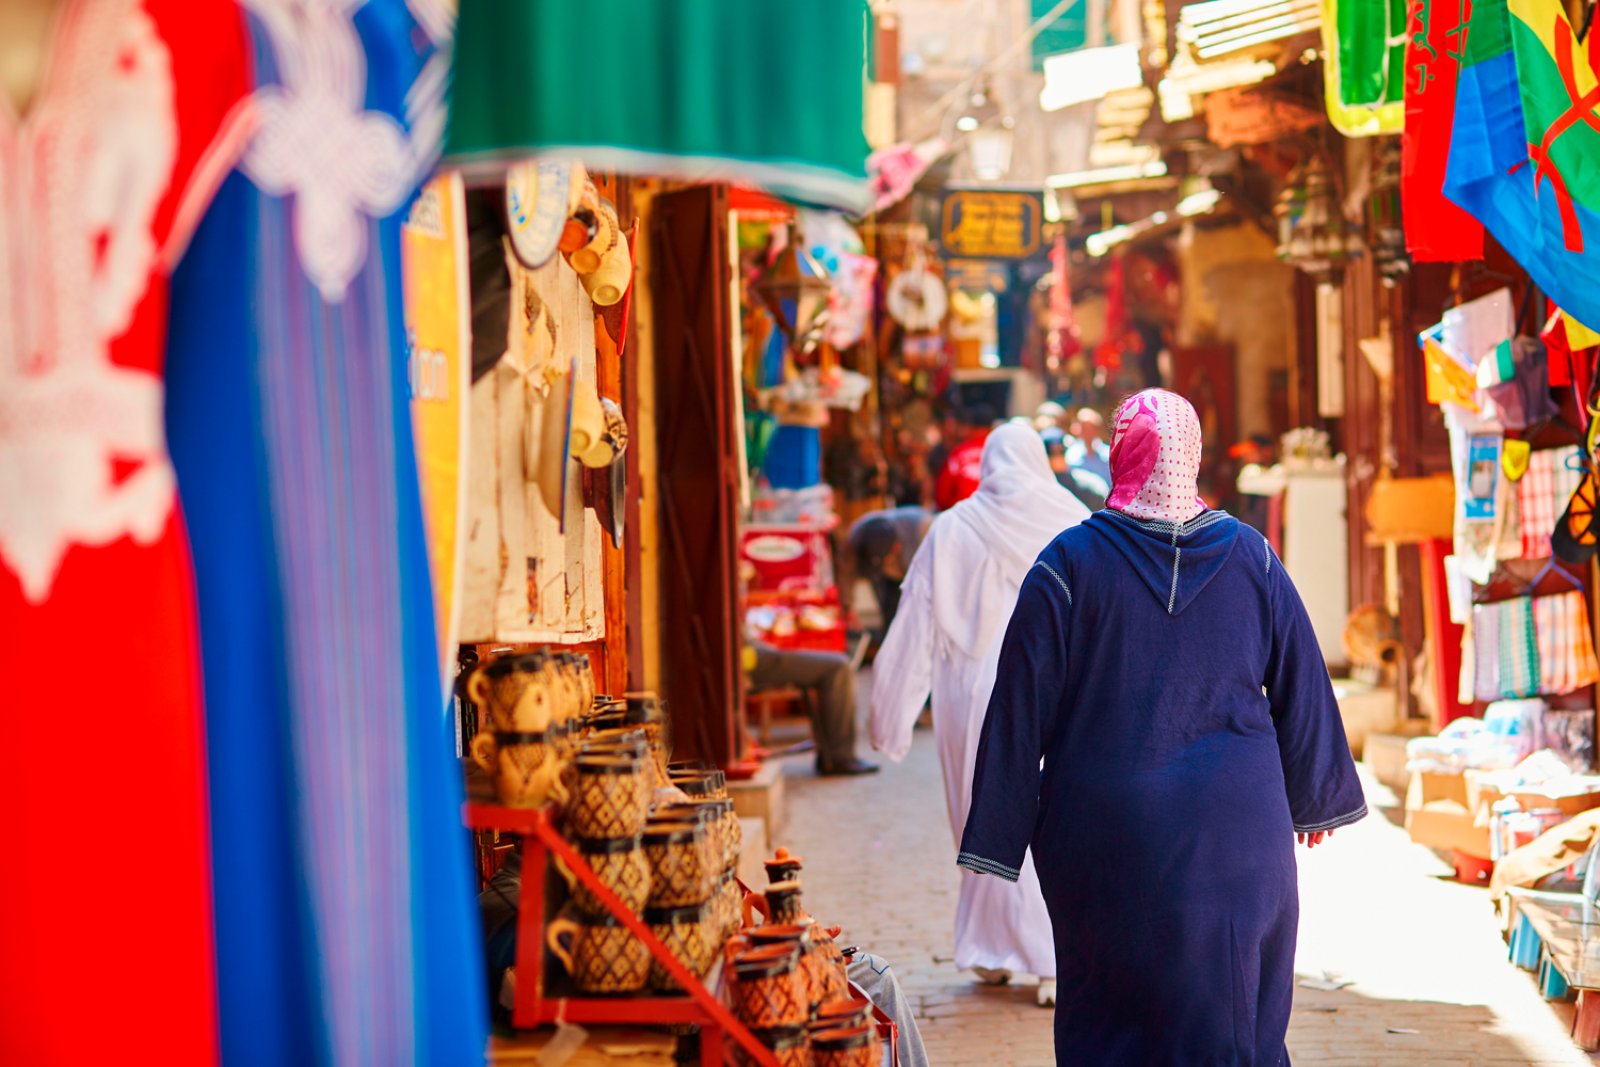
[1106,389,1205,523]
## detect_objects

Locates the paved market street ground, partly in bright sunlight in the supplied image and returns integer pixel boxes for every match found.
[779,681,1600,1067]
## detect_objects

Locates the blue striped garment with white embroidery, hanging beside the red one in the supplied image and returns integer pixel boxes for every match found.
[167,0,488,1067]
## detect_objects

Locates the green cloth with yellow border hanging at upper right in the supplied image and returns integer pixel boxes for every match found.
[1322,0,1406,138]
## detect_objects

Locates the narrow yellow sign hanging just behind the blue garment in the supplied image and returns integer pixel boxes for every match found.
[400,174,472,694]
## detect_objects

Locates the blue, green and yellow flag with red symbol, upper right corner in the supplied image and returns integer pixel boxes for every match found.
[1445,0,1600,323]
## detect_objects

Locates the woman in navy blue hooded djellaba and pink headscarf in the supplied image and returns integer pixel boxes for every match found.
[958,390,1366,1067]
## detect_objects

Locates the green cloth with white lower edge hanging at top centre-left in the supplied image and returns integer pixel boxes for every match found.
[445,0,870,211]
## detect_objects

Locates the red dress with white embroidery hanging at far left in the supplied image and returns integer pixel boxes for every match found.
[0,0,248,1067]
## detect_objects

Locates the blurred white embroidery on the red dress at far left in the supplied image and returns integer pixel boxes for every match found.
[0,0,178,603]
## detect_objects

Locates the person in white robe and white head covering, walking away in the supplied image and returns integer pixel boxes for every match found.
[870,422,1090,1006]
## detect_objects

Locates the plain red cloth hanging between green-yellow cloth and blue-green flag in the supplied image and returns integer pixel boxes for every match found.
[1400,0,1483,262]
